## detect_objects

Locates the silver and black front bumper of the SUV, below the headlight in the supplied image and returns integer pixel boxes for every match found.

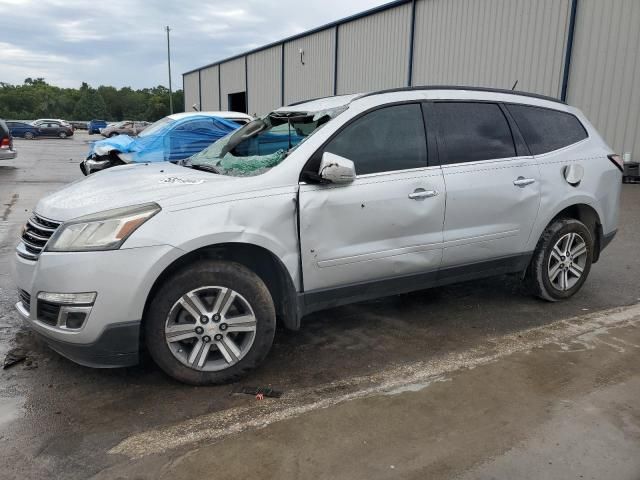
[14,245,181,367]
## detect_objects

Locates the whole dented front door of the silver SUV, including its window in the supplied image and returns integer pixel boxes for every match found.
[300,103,445,292]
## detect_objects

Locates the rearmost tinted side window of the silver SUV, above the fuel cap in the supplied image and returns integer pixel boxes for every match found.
[507,104,588,155]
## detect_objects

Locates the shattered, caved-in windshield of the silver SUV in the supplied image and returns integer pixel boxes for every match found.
[183,106,347,177]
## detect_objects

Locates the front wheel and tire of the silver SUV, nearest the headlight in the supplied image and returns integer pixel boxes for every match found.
[143,260,276,385]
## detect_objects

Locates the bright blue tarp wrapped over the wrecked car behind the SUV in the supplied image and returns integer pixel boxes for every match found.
[87,115,240,163]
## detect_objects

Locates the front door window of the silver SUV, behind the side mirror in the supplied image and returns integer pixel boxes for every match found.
[324,103,427,175]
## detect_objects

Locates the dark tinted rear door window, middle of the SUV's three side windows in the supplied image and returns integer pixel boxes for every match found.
[434,102,516,164]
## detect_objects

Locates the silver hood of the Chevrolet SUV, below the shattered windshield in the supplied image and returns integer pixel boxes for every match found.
[35,162,235,222]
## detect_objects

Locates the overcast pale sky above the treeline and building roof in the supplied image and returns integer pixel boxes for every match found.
[0,0,388,88]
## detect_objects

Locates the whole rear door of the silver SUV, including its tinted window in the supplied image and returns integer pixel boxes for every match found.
[431,101,540,268]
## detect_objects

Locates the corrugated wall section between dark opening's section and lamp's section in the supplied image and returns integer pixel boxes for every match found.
[247,45,282,115]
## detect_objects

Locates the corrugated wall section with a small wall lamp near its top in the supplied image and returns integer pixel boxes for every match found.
[284,28,335,105]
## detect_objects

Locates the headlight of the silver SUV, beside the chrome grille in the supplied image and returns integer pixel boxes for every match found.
[46,203,160,252]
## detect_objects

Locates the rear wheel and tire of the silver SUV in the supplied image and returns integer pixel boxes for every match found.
[526,218,594,302]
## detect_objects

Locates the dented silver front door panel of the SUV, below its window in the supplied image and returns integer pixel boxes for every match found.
[300,167,446,291]
